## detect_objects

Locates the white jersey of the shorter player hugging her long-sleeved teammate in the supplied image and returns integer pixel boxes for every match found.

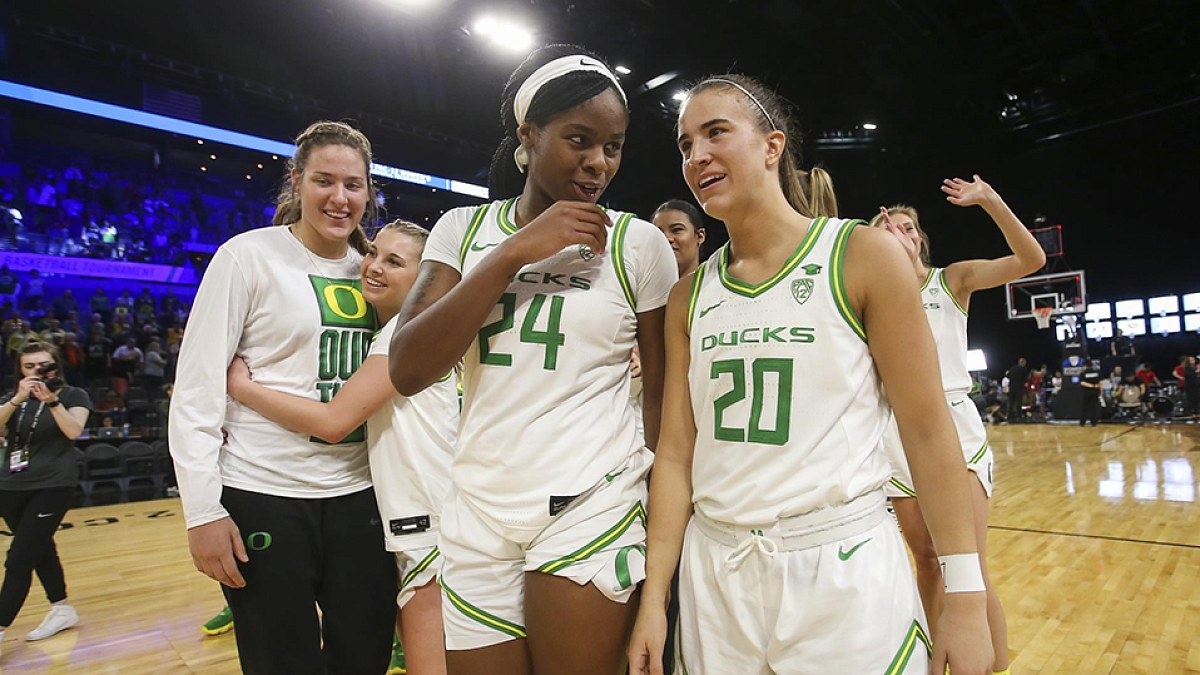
[367,316,458,551]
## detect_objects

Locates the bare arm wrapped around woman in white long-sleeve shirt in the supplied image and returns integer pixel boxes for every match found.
[226,354,396,443]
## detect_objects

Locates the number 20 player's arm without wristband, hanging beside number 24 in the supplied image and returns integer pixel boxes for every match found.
[629,275,696,675]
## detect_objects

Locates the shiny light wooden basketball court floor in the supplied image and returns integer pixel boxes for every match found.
[0,425,1200,675]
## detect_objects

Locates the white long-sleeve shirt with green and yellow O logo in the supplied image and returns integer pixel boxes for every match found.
[169,227,376,527]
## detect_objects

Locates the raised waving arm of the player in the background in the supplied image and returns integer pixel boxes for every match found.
[942,174,1046,300]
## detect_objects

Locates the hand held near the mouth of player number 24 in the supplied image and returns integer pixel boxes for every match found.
[505,202,612,269]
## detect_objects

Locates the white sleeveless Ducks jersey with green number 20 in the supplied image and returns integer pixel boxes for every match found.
[689,217,890,527]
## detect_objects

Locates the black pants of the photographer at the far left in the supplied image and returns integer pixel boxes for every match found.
[0,488,74,627]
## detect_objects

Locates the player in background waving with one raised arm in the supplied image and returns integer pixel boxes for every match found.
[871,175,1045,673]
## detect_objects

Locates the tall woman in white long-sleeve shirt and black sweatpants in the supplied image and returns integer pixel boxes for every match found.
[169,121,396,675]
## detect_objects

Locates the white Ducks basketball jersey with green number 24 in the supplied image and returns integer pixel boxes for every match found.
[424,199,677,526]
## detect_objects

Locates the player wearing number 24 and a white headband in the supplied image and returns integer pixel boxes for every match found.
[390,46,676,675]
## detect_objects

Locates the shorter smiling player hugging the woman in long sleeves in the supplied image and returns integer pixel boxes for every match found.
[228,220,458,675]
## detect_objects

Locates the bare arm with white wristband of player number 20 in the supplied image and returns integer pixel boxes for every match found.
[845,227,992,675]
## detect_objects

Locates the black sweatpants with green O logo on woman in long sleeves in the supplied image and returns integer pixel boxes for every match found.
[221,488,396,675]
